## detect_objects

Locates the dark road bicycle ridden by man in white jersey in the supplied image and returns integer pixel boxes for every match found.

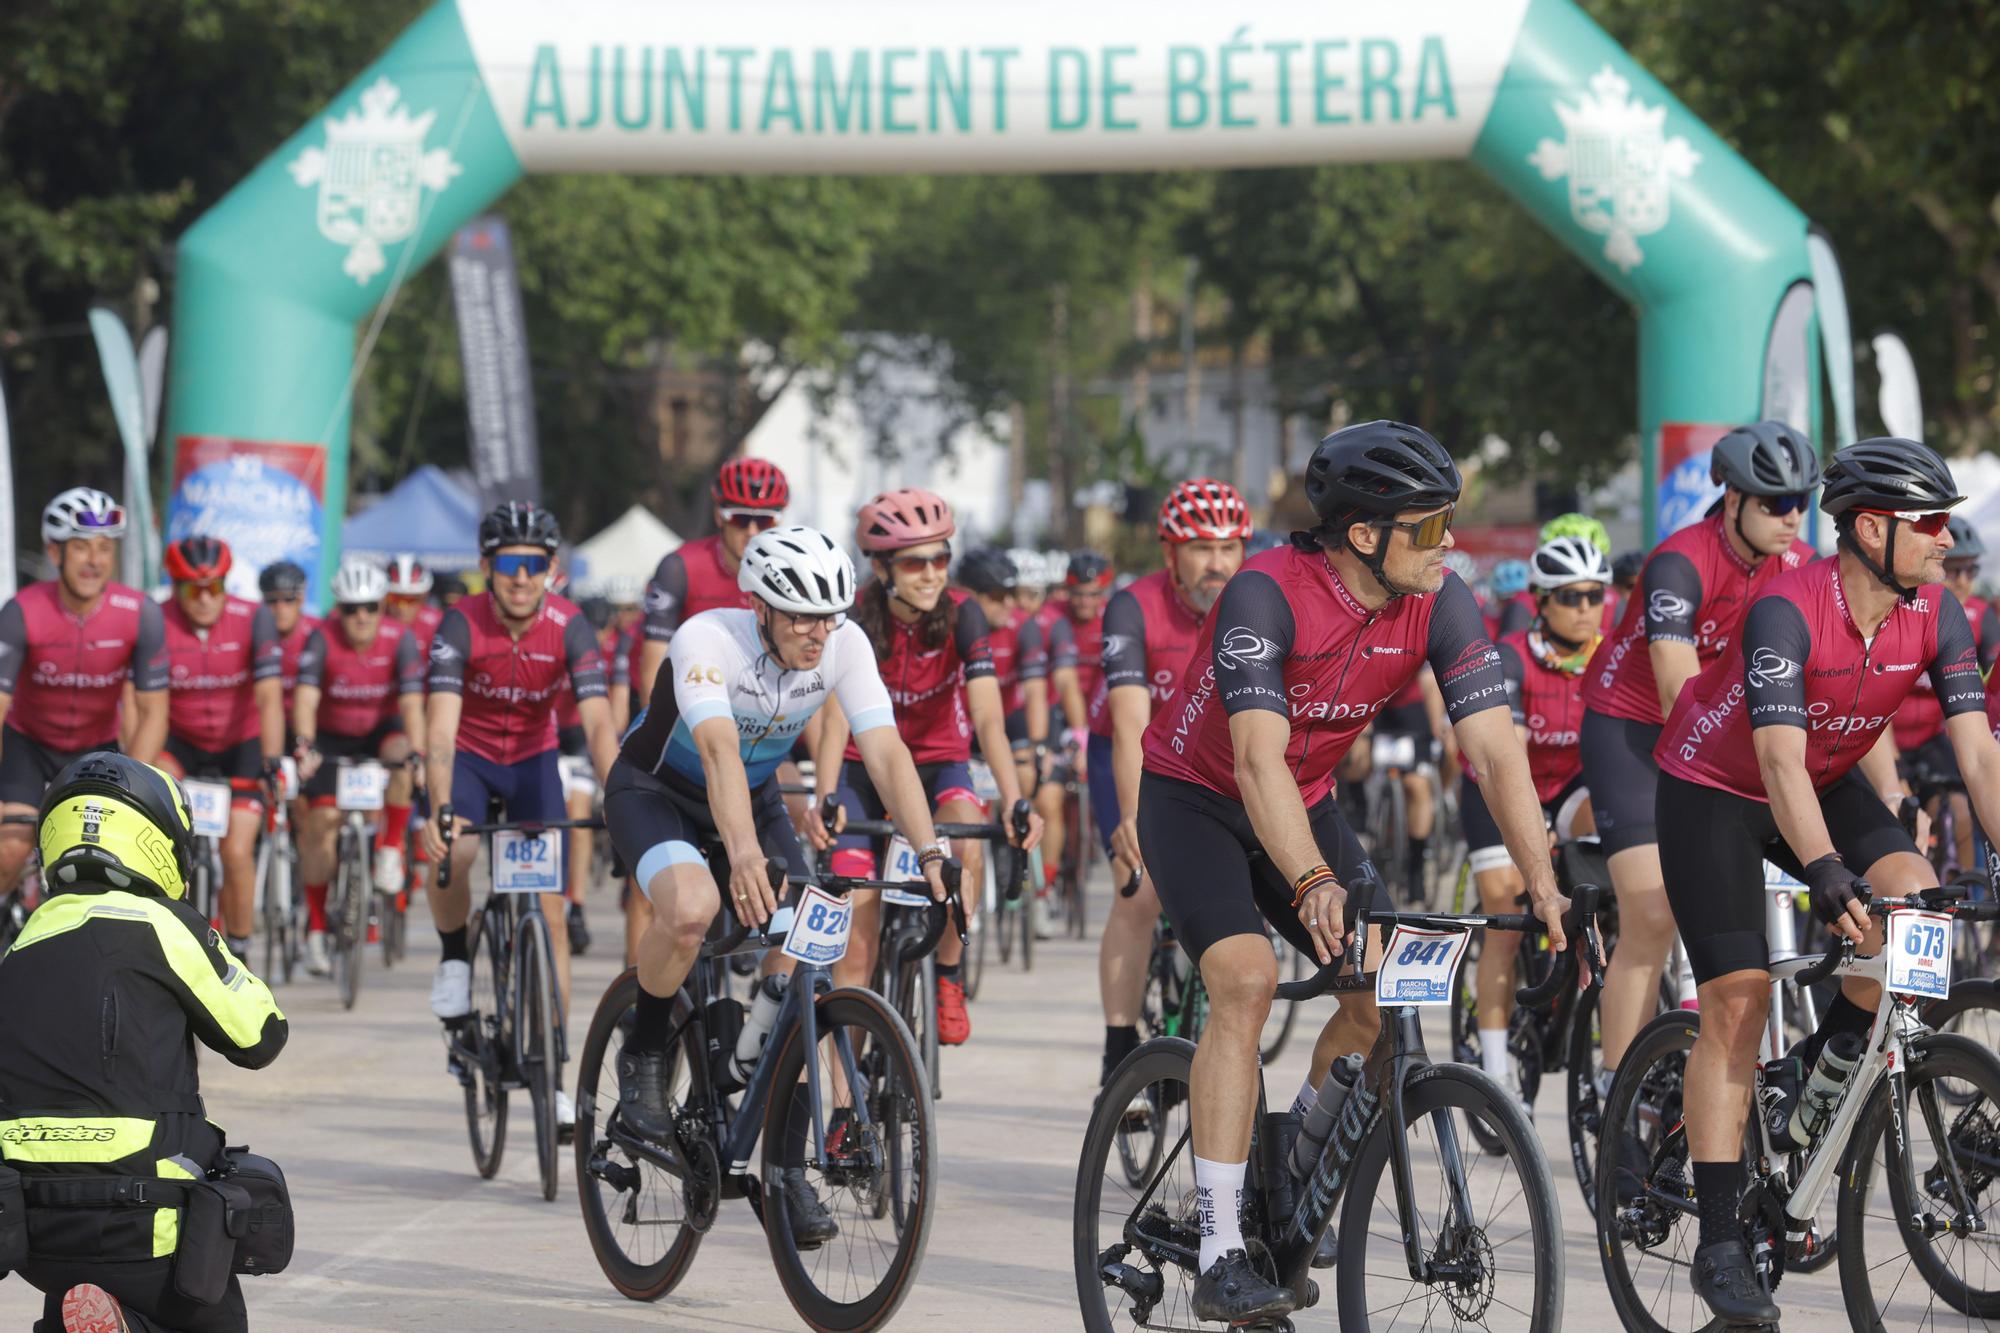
[576,845,964,1333]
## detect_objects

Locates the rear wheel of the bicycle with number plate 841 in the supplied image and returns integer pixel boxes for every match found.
[1070,1037,1192,1333]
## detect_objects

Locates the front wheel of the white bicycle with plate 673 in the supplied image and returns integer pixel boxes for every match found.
[1838,1035,2000,1333]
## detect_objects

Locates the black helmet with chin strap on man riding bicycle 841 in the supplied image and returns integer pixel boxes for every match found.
[1292,420,1464,596]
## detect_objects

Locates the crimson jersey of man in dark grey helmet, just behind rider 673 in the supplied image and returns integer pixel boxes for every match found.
[1584,514,1812,725]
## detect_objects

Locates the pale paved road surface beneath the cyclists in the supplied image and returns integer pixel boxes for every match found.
[0,868,1872,1333]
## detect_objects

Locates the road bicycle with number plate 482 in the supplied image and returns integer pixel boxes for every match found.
[438,799,604,1199]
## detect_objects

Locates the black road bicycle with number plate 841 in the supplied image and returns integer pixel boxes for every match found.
[1074,887,1600,1333]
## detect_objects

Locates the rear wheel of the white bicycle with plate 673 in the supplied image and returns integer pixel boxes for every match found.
[1596,1009,1722,1333]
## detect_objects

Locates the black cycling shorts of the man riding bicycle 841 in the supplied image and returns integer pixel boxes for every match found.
[1138,773,1374,961]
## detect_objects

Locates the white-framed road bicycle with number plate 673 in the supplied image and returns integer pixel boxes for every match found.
[1596,885,2000,1333]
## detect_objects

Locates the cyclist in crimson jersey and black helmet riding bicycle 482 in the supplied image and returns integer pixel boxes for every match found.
[424,500,618,1125]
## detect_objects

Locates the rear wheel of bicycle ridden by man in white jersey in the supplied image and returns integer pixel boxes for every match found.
[576,971,712,1301]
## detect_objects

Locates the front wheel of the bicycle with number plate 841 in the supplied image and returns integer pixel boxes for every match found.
[1338,1065,1562,1333]
